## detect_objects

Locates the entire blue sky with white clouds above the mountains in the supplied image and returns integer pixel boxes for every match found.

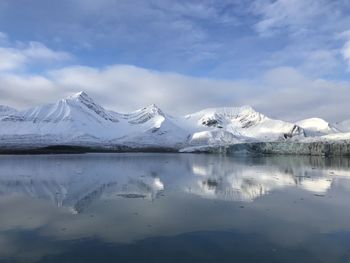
[0,0,350,122]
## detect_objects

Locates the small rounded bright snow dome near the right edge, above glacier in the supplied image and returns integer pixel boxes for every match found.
[296,118,339,136]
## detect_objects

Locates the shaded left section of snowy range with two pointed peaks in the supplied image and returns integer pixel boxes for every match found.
[0,92,187,147]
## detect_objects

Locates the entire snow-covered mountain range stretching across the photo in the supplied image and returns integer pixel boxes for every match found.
[0,92,350,154]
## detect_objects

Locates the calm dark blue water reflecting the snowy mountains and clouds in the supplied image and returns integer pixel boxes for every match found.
[0,154,350,263]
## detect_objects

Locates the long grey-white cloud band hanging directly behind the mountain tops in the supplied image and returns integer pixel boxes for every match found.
[0,62,350,121]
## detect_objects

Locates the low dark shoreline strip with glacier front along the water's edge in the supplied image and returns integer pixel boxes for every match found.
[0,141,350,156]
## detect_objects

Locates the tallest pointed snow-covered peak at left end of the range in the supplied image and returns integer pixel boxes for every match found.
[0,92,119,140]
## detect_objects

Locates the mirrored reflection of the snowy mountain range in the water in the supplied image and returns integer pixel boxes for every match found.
[0,154,350,213]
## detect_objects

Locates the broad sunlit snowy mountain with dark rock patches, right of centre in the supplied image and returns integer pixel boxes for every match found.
[180,106,304,145]
